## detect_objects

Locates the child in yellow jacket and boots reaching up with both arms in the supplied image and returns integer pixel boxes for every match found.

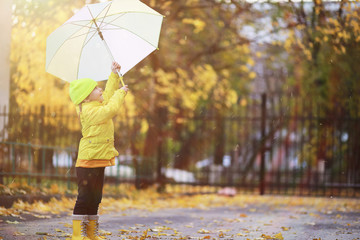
[70,62,128,240]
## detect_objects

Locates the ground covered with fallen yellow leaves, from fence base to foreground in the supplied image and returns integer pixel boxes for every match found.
[0,183,360,240]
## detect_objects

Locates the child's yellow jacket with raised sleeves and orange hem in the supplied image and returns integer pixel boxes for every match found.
[76,72,126,168]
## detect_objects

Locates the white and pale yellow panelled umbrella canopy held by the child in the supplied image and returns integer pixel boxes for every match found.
[46,0,163,82]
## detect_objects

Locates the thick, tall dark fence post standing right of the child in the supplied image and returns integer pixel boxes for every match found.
[260,93,266,195]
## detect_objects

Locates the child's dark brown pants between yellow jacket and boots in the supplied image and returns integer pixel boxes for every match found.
[73,167,105,215]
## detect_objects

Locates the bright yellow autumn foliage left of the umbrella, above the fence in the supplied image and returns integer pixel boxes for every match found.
[10,1,84,116]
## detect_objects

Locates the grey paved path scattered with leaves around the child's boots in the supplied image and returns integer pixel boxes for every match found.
[0,197,360,240]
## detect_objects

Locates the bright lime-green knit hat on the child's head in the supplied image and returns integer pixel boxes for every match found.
[69,78,97,105]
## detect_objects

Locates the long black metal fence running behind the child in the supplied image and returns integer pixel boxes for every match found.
[0,94,360,196]
